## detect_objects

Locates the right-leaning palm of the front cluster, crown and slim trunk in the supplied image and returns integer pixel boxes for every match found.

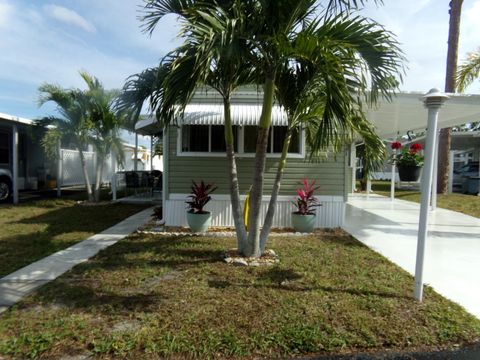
[260,15,401,251]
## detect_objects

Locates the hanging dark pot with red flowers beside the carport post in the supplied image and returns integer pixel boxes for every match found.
[391,141,424,181]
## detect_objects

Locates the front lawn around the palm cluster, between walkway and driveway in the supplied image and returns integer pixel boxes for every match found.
[0,231,480,359]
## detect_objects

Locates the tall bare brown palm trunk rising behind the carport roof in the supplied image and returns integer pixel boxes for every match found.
[437,0,463,194]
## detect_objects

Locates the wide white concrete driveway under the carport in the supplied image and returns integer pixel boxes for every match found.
[343,195,480,318]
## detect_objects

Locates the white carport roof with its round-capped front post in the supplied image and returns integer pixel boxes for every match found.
[367,89,480,301]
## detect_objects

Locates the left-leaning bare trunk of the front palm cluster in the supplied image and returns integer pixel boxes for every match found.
[223,99,247,254]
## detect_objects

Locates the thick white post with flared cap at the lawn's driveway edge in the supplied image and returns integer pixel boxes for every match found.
[414,89,448,301]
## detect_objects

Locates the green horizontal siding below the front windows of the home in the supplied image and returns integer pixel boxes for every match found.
[167,127,347,196]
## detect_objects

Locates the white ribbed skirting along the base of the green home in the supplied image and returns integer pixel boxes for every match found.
[164,194,345,228]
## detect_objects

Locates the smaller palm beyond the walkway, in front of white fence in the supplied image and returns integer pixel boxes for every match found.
[39,71,124,201]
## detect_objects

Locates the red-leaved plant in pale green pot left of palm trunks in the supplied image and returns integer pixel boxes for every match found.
[186,180,217,232]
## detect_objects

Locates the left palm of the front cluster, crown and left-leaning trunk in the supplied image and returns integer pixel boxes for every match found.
[125,1,253,253]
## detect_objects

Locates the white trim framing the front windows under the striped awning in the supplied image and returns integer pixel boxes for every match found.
[177,125,305,159]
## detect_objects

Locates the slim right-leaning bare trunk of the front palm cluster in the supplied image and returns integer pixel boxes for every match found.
[260,127,293,253]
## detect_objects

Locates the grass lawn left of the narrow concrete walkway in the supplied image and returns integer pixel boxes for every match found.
[0,199,149,277]
